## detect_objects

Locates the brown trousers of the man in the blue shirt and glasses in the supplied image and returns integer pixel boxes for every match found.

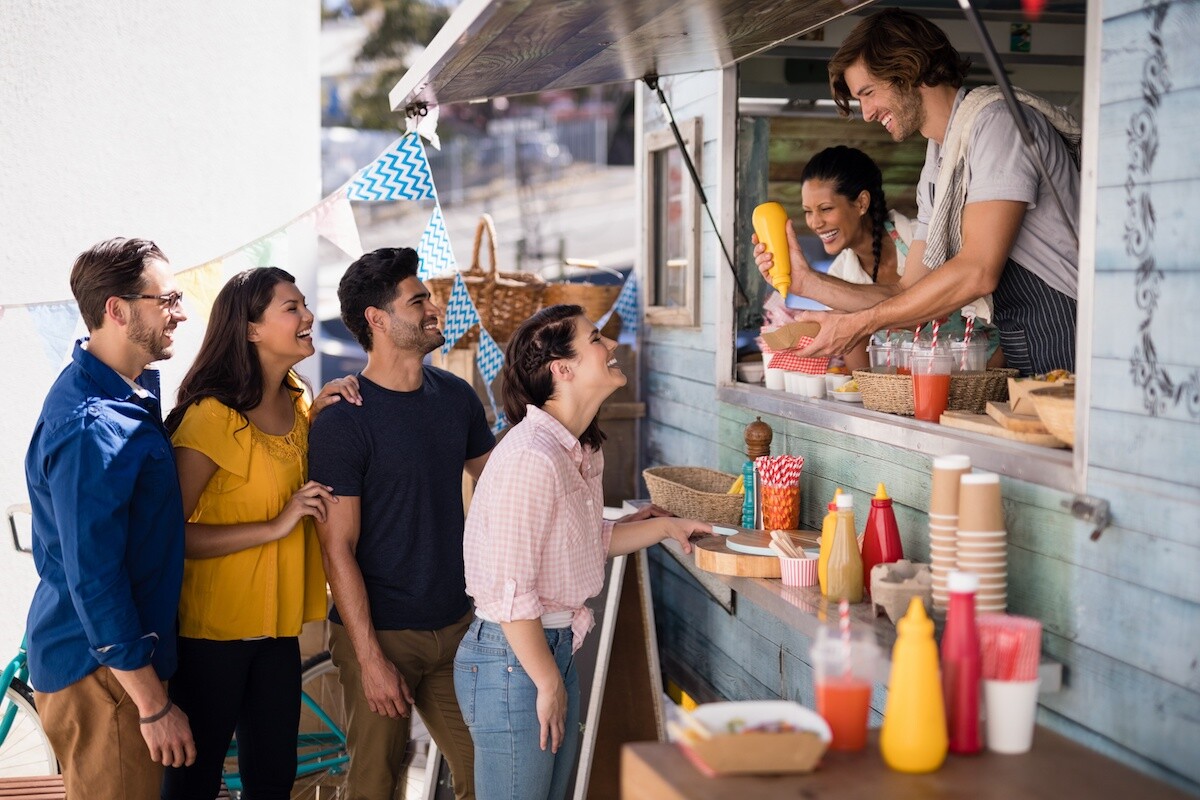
[34,667,163,800]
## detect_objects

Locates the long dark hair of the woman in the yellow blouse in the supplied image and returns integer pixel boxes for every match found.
[167,266,304,433]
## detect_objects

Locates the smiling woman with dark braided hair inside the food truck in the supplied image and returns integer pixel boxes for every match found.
[755,145,1000,369]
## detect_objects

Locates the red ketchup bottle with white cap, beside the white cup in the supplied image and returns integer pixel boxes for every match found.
[942,571,983,754]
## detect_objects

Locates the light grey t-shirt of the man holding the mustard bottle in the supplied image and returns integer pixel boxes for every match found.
[914,89,1079,299]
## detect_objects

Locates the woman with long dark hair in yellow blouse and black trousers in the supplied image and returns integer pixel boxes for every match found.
[162,267,361,800]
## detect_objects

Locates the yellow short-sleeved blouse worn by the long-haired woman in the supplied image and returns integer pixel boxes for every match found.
[172,398,326,640]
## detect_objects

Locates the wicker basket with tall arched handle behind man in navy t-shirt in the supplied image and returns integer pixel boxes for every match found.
[425,213,546,349]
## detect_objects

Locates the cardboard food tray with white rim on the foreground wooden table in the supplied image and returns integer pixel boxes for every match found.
[684,700,832,775]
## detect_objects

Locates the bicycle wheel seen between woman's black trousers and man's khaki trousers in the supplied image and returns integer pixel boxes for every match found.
[292,651,349,800]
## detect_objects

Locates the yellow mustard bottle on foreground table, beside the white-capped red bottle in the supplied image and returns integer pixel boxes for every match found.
[880,597,949,772]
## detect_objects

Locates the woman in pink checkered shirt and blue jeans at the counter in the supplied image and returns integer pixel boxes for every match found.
[455,306,712,800]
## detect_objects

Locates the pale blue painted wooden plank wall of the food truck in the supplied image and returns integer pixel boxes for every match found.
[646,0,1200,793]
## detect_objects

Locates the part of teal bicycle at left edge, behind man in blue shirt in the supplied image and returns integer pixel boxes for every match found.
[0,503,59,777]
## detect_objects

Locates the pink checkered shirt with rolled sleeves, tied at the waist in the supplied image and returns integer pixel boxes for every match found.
[463,405,613,650]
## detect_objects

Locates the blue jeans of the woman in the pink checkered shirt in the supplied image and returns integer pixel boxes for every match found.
[454,619,580,800]
